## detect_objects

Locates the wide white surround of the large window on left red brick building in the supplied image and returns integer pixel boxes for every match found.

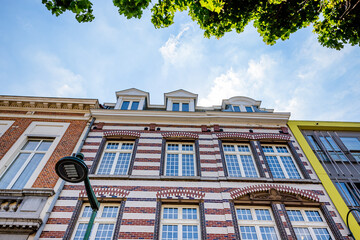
[0,122,70,188]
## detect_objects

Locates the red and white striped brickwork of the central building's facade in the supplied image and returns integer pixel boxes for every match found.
[41,123,347,240]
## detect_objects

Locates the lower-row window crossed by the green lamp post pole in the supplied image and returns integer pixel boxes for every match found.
[73,204,119,240]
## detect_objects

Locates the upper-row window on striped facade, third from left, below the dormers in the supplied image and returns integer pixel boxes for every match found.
[223,143,258,177]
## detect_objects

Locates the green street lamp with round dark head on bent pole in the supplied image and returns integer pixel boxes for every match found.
[55,153,100,240]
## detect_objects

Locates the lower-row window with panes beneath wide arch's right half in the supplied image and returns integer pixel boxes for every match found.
[287,208,333,240]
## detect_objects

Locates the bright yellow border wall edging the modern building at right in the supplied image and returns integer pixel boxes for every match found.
[288,121,360,240]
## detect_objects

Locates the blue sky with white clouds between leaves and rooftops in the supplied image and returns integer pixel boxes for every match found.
[0,0,360,121]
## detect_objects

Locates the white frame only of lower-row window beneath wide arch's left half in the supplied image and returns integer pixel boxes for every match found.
[235,206,281,240]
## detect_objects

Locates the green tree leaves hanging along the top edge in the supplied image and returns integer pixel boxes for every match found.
[42,0,360,50]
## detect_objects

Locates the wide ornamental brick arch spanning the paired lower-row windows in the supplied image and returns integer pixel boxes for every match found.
[230,184,319,203]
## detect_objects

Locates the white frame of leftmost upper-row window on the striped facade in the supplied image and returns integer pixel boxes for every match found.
[96,141,135,175]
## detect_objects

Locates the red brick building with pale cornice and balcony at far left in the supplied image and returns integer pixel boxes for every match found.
[0,96,98,240]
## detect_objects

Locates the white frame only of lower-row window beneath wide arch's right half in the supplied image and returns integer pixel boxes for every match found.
[286,207,335,240]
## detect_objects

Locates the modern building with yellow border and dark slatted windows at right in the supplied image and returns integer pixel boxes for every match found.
[288,121,360,239]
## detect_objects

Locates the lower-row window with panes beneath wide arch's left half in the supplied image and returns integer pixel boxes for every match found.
[236,207,280,240]
